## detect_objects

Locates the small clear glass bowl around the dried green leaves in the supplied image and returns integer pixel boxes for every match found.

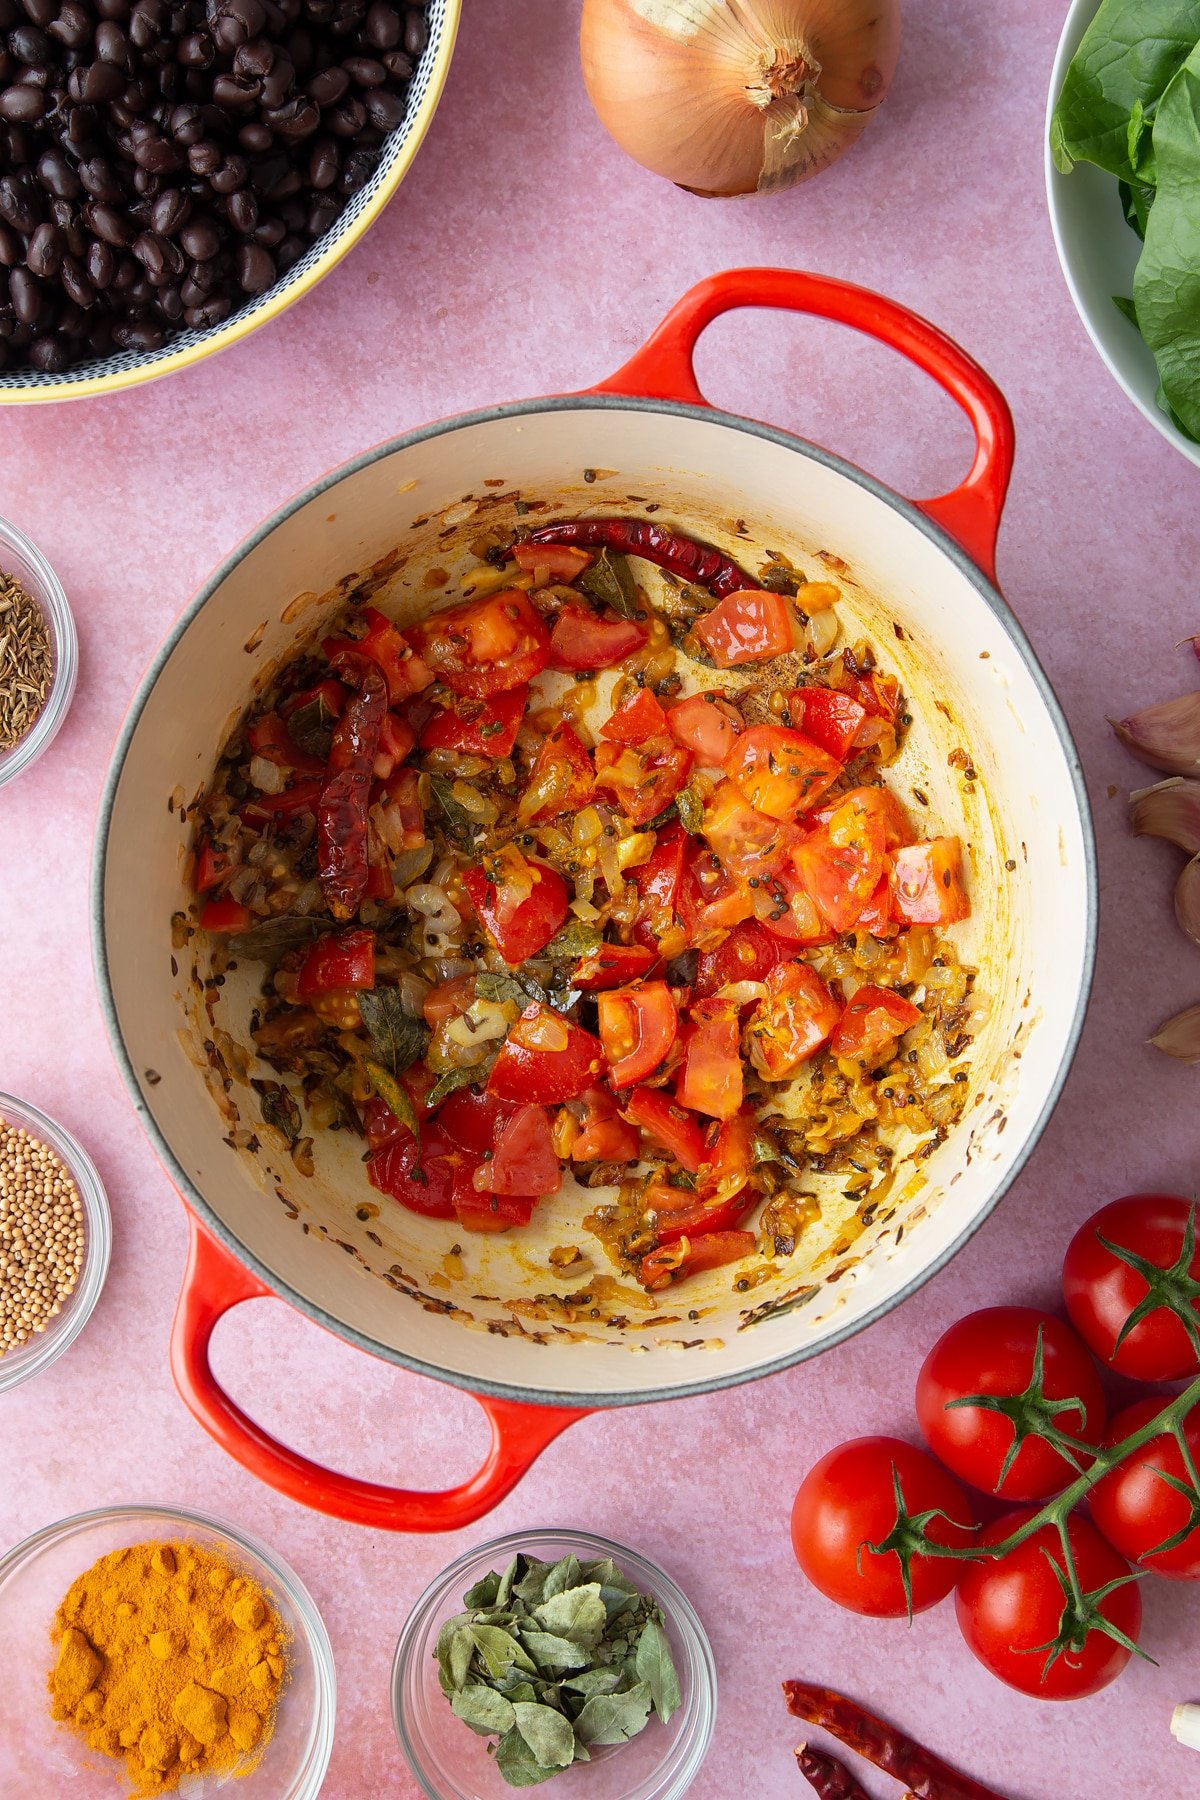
[392,1530,716,1800]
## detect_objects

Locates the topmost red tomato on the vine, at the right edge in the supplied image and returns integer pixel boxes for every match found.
[1057,1195,1200,1381]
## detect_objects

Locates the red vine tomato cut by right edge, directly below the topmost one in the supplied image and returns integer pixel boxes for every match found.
[1087,1400,1200,1580]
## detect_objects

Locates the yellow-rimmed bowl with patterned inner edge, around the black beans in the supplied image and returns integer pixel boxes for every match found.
[0,0,462,405]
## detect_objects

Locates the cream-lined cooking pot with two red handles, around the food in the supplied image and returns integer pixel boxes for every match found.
[94,270,1096,1530]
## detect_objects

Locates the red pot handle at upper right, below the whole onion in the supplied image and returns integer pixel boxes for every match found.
[588,268,1015,581]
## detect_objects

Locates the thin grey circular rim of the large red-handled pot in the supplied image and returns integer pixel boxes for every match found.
[90,392,1099,1408]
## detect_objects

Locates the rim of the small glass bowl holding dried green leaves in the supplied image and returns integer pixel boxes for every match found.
[389,1525,720,1800]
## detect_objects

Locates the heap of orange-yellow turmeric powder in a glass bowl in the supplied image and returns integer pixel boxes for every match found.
[49,1543,284,1796]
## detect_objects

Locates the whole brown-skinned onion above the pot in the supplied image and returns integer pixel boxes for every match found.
[579,0,900,198]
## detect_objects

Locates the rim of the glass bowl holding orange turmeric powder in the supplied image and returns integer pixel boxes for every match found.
[0,1501,336,1800]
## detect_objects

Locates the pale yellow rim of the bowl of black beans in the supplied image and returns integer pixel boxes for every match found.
[0,0,462,407]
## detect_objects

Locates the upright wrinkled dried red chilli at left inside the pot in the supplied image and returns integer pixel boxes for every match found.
[317,657,387,918]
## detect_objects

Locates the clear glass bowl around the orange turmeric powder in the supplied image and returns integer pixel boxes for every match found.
[0,1507,335,1800]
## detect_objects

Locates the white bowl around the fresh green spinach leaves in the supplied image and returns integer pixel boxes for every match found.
[1043,0,1200,466]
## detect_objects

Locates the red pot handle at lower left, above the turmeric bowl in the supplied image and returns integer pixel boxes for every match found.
[171,1211,590,1532]
